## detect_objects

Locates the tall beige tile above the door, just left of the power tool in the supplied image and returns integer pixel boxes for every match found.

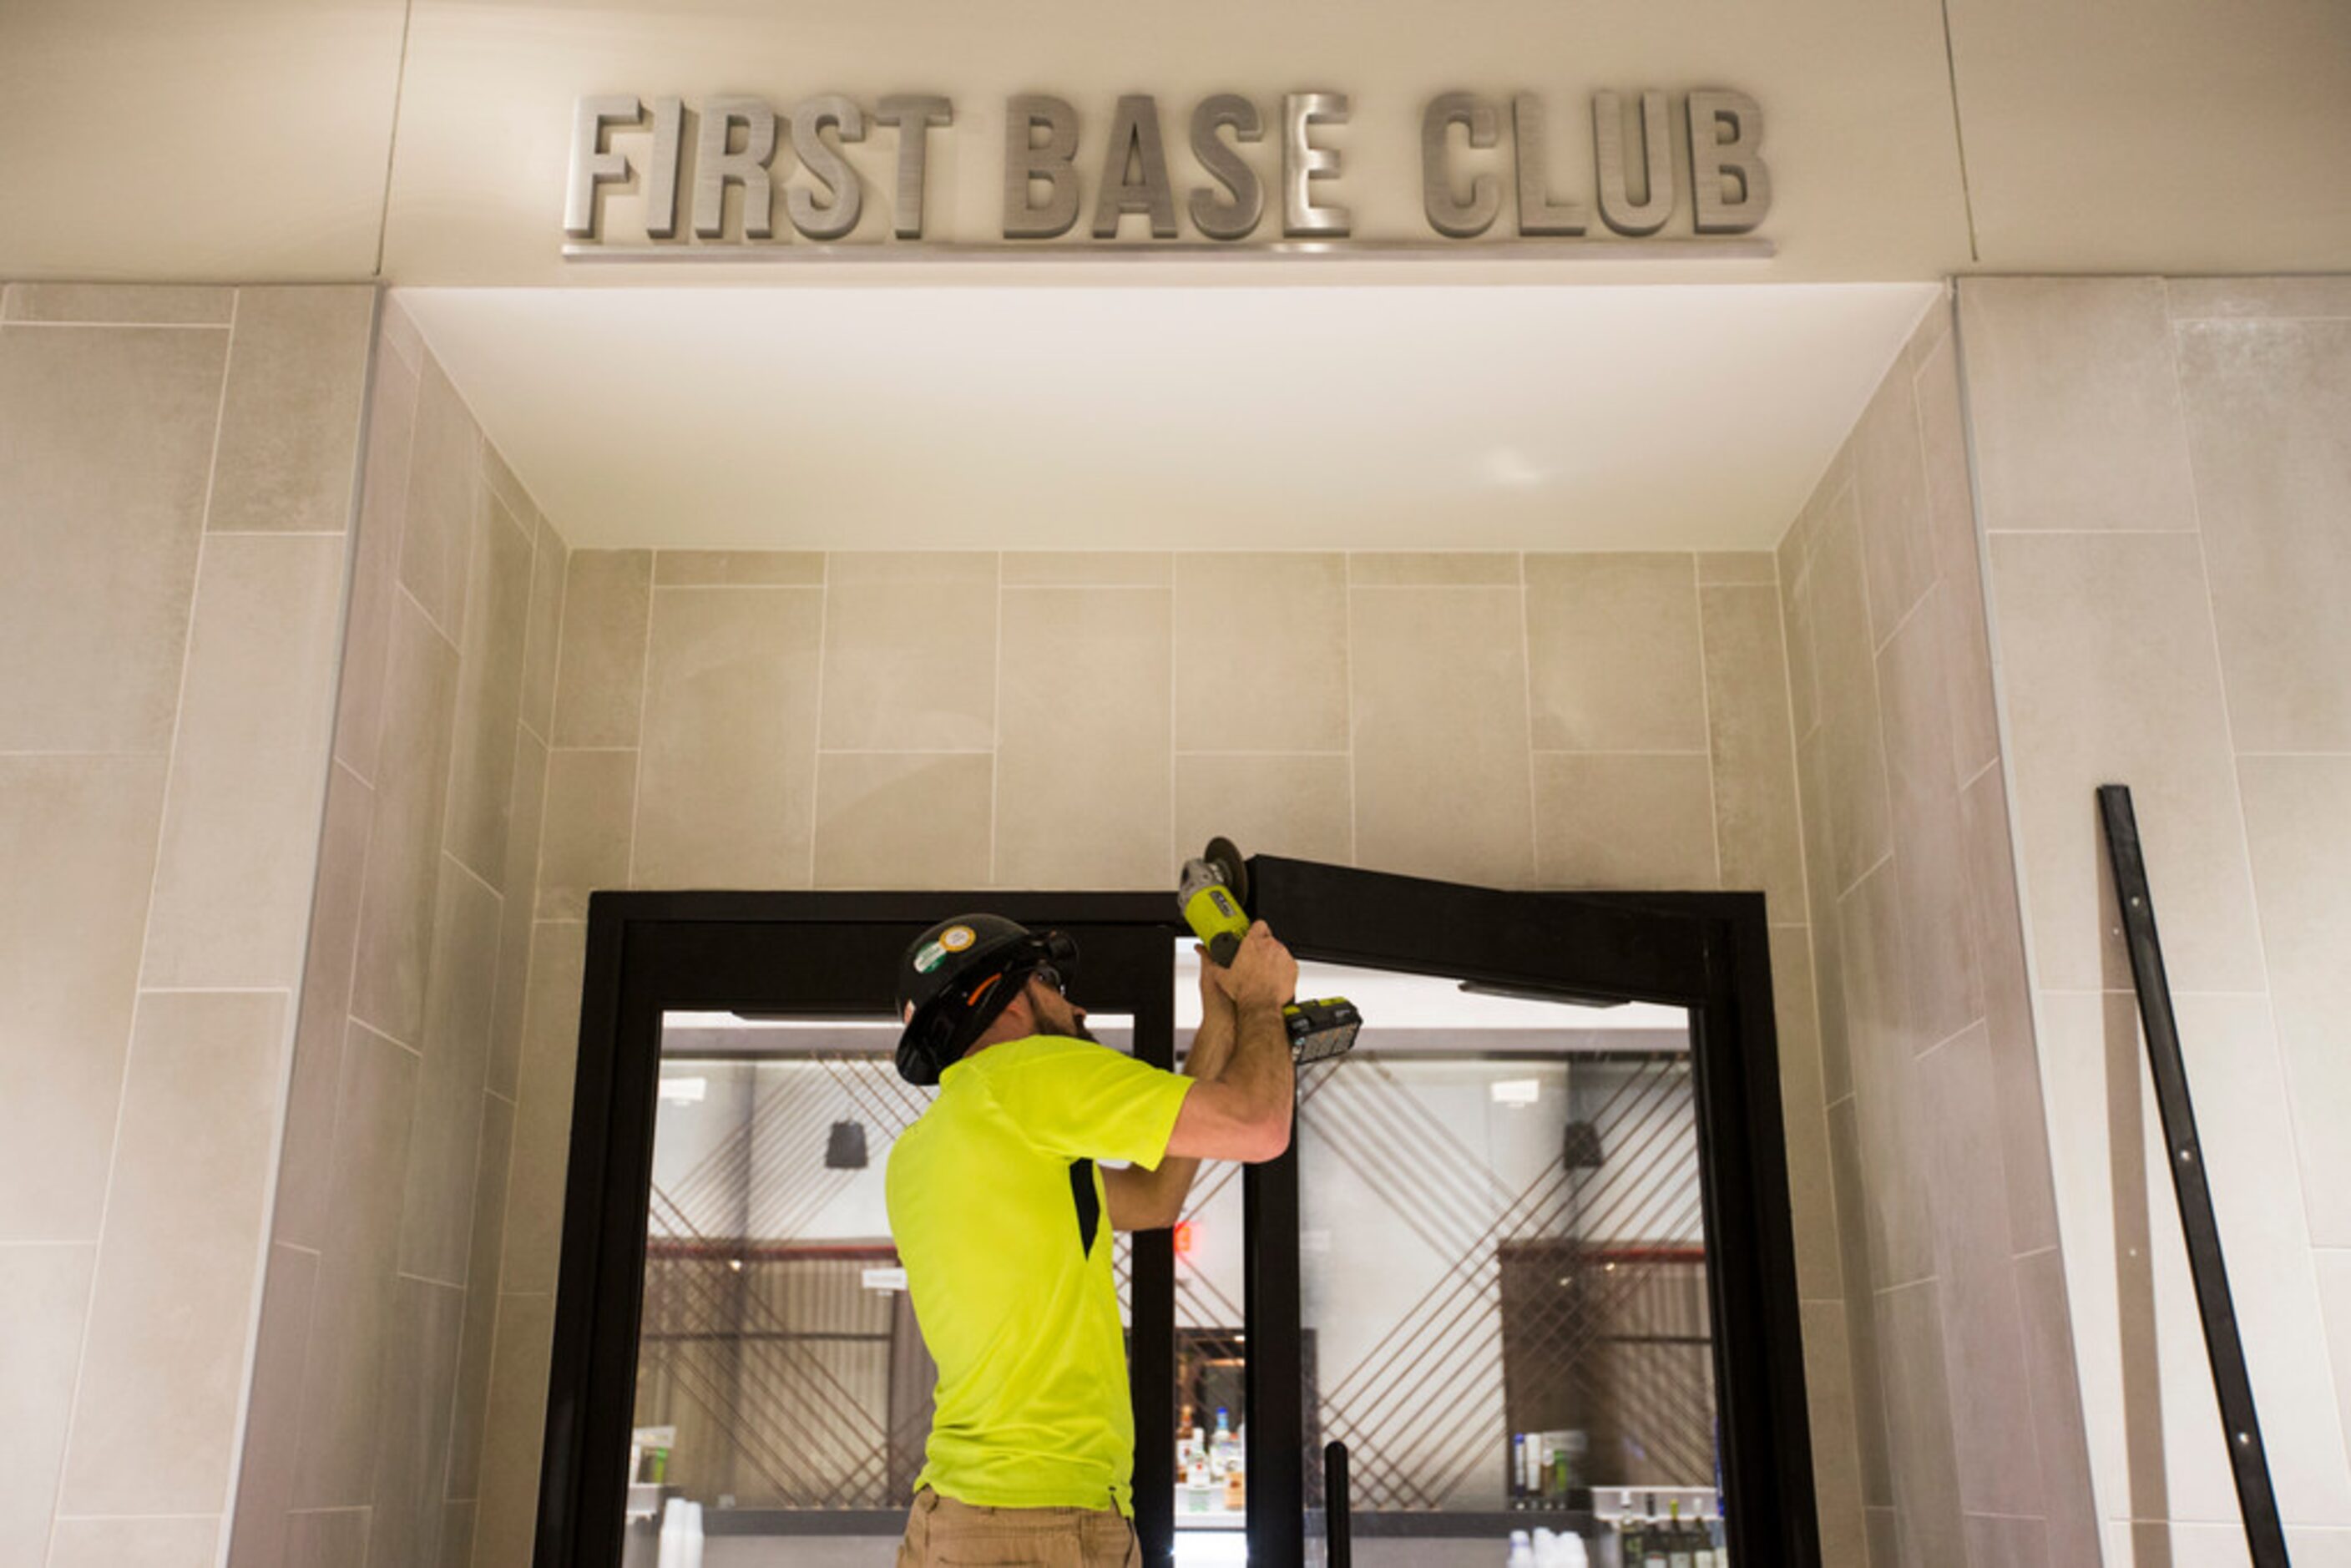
[997,588,1173,886]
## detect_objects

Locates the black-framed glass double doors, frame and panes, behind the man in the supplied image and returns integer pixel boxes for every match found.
[533,858,1818,1568]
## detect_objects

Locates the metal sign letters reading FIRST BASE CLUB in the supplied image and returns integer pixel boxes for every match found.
[564,87,1770,254]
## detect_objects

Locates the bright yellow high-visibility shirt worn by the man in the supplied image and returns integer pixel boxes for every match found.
[887,1034,1192,1514]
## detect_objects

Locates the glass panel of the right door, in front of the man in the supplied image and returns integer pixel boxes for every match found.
[1260,964,1716,1561]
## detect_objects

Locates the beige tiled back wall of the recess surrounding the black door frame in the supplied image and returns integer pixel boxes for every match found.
[475,550,1862,1568]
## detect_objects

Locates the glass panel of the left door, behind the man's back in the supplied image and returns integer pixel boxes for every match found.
[623,1014,1133,1568]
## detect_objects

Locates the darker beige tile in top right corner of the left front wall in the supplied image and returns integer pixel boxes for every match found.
[207,285,377,534]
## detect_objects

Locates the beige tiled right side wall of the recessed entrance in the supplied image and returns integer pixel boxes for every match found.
[1777,293,2097,1568]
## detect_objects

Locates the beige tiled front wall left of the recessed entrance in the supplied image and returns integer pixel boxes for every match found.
[0,285,374,1568]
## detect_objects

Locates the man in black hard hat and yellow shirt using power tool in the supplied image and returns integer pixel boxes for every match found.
[888,914,1297,1568]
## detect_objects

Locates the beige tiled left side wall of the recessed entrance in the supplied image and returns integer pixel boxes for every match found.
[224,303,567,1568]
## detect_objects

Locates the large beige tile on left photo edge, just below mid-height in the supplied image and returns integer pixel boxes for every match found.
[0,757,164,1242]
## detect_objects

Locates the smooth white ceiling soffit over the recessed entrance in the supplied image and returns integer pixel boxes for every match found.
[397,285,1937,550]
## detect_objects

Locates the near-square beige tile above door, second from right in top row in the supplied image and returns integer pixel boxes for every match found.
[1526,553,1706,752]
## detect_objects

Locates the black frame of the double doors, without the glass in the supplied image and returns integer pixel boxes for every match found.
[531,879,1820,1568]
